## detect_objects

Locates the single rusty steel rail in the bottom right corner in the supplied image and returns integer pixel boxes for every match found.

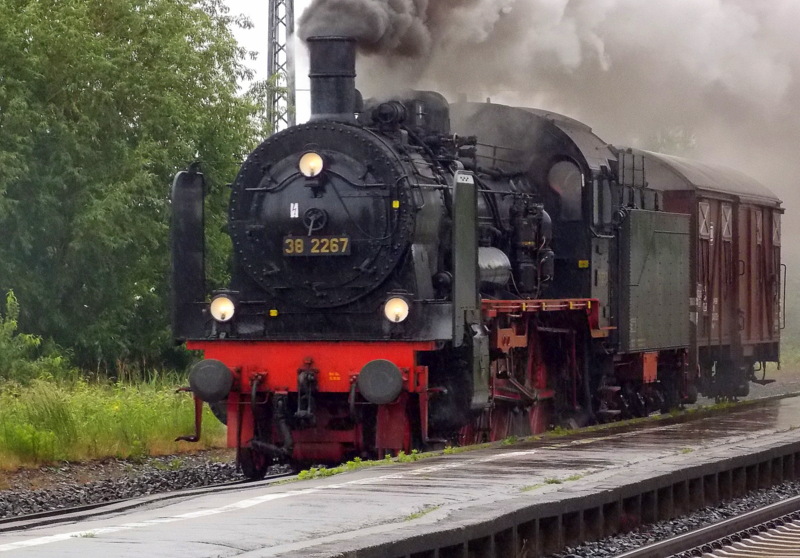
[615,496,800,558]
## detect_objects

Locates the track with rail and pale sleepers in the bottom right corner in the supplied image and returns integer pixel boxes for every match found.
[616,496,800,558]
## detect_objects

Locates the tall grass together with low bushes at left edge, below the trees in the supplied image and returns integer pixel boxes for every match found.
[0,292,224,469]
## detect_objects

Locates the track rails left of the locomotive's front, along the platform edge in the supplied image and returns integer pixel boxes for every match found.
[0,473,296,533]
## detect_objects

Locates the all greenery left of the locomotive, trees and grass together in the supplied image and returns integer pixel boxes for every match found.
[0,0,273,468]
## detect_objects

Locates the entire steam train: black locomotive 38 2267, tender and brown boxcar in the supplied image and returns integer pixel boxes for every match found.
[172,37,781,478]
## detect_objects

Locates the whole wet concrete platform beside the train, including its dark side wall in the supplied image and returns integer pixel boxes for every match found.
[0,398,800,558]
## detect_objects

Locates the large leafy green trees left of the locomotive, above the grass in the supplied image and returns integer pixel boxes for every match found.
[0,0,263,372]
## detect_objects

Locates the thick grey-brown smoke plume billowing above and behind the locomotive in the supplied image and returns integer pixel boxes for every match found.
[300,0,800,217]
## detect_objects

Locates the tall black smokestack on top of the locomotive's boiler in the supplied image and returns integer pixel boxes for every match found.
[306,37,356,122]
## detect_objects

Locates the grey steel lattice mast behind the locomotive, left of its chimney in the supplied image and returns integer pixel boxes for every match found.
[267,0,297,132]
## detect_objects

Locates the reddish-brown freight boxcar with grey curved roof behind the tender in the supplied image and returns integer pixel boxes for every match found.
[627,151,785,397]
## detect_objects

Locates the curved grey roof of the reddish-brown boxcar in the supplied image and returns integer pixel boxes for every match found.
[633,149,781,205]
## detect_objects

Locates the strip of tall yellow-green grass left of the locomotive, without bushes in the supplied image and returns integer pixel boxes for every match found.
[0,379,224,469]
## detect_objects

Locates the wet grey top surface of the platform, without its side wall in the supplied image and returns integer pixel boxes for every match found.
[0,398,800,558]
